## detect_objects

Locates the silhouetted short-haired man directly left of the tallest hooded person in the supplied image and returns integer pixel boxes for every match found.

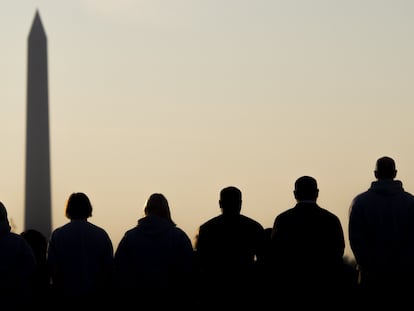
[271,176,356,310]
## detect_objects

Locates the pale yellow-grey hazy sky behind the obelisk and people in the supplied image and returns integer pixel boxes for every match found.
[0,0,414,256]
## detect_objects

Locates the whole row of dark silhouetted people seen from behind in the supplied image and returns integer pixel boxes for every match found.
[0,157,414,310]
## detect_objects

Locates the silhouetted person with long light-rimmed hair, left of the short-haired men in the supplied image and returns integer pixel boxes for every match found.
[114,193,194,310]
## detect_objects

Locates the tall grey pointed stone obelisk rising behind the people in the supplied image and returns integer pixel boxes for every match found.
[24,11,52,238]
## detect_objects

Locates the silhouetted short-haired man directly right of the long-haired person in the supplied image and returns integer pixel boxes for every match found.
[194,186,266,309]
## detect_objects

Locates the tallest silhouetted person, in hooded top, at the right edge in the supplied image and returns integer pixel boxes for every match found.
[348,157,414,306]
